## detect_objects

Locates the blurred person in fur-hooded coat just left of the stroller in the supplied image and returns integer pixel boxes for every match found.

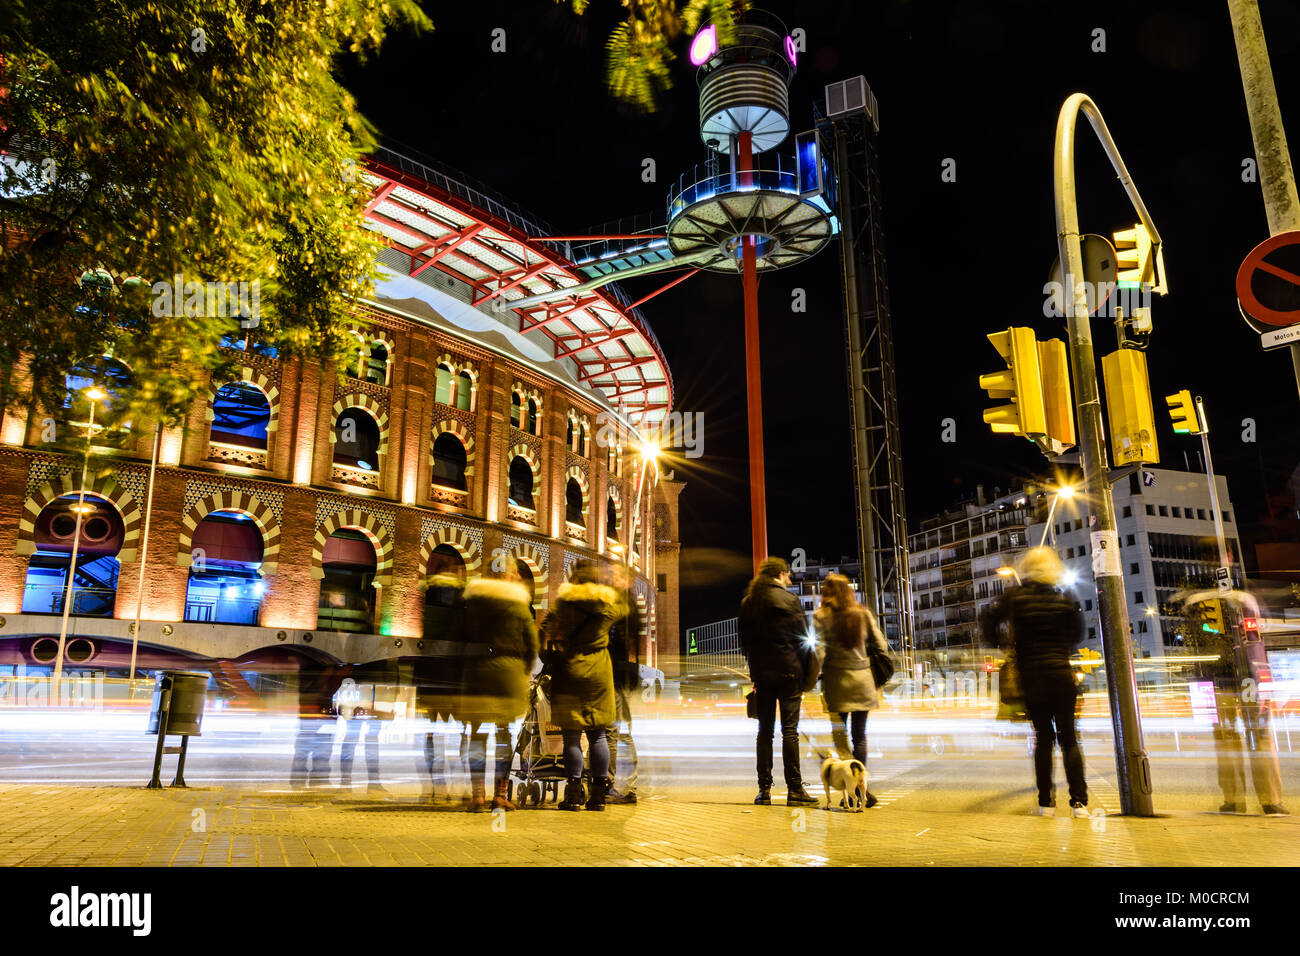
[456,571,538,812]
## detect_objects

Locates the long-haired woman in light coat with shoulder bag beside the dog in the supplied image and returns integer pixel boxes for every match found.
[813,574,889,809]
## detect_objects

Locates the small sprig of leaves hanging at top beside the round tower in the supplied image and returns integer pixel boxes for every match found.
[555,0,750,112]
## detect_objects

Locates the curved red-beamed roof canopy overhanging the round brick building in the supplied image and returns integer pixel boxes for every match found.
[364,148,672,424]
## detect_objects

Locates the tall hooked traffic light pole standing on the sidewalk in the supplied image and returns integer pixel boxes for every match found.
[1053,92,1160,817]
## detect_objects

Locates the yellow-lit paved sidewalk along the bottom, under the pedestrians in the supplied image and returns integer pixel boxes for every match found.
[0,783,1300,866]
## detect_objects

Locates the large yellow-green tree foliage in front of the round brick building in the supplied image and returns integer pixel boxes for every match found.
[0,0,430,421]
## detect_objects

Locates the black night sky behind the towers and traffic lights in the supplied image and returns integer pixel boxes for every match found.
[345,0,1300,626]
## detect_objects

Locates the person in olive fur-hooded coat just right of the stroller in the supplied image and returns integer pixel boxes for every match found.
[542,561,625,810]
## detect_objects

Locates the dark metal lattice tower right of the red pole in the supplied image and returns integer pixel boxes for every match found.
[816,77,915,671]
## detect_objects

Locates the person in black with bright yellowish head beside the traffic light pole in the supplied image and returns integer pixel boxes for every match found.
[987,548,1088,817]
